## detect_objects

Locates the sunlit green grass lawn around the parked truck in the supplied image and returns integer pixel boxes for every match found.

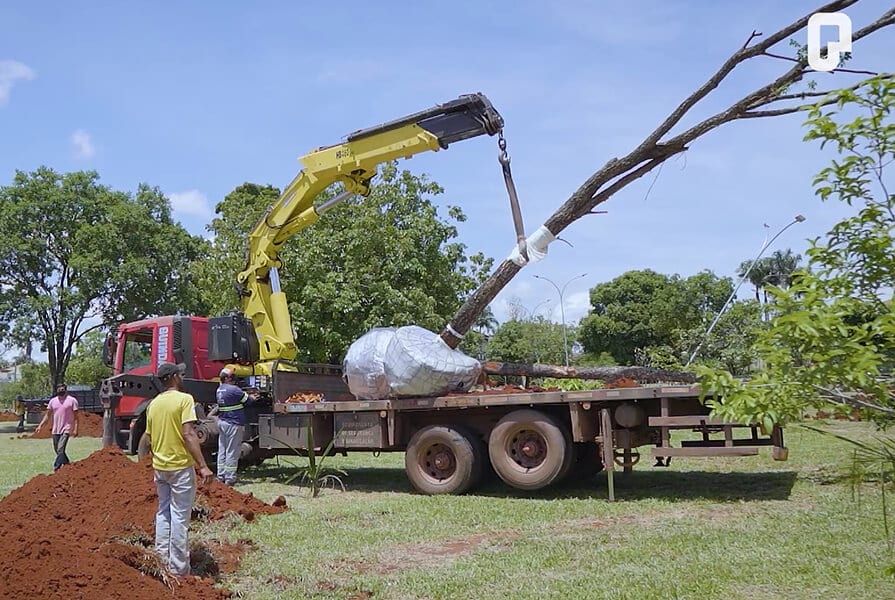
[0,422,895,600]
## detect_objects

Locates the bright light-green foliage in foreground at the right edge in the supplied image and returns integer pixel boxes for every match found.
[703,75,895,426]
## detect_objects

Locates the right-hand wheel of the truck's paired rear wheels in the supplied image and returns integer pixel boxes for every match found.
[488,409,574,490]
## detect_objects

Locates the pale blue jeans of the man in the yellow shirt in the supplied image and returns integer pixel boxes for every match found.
[155,467,196,575]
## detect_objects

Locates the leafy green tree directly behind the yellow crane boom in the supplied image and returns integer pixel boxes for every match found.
[195,164,491,362]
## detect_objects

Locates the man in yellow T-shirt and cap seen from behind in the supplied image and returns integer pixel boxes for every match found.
[140,362,214,576]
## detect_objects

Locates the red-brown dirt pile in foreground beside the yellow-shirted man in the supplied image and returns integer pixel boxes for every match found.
[0,448,285,600]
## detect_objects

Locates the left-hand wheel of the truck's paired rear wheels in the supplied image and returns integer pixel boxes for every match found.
[404,425,484,494]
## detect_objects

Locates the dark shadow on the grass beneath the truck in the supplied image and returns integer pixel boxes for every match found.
[241,462,797,502]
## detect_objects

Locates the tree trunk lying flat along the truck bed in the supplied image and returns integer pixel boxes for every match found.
[483,361,696,383]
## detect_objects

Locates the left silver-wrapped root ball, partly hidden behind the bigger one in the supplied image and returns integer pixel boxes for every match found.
[342,327,395,400]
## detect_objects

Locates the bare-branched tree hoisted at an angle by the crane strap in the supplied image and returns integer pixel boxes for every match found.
[441,0,895,348]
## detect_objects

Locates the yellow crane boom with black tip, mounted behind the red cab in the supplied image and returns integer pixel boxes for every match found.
[236,94,503,372]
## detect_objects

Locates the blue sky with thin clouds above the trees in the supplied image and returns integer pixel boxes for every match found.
[0,0,895,328]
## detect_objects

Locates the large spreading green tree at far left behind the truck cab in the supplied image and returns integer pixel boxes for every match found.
[0,167,204,383]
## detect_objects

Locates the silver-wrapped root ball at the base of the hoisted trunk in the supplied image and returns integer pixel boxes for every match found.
[385,325,482,396]
